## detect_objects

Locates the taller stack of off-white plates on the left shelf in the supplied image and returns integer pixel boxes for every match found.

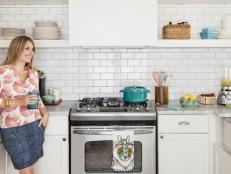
[33,21,61,40]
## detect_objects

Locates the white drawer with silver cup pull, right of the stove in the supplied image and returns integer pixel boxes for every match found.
[158,115,208,133]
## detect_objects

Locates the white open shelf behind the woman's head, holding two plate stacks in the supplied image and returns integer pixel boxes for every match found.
[0,40,69,48]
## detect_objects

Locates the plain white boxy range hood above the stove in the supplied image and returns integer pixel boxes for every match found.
[69,0,157,47]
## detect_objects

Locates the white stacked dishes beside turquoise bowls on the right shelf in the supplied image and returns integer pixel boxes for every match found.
[219,15,231,39]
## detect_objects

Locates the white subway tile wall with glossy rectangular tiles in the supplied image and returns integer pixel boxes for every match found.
[0,4,231,100]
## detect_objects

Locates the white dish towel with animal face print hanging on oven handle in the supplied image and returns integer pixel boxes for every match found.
[112,130,134,172]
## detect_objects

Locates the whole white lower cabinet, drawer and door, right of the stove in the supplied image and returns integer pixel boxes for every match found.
[158,115,210,174]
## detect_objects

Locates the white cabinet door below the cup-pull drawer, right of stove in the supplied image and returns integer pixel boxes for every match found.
[158,134,209,174]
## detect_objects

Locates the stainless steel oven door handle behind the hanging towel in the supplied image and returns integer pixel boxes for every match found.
[73,130,153,135]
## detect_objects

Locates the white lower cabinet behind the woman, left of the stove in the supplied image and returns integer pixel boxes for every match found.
[0,112,68,174]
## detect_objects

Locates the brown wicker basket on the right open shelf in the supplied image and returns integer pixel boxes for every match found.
[163,22,191,39]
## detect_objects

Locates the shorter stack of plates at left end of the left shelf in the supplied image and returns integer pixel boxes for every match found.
[1,28,26,39]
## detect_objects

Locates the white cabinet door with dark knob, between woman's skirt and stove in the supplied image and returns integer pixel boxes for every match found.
[35,136,68,174]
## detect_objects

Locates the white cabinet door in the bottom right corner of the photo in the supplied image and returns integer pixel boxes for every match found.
[215,145,231,174]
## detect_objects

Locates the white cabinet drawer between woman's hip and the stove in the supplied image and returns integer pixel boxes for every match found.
[45,116,68,135]
